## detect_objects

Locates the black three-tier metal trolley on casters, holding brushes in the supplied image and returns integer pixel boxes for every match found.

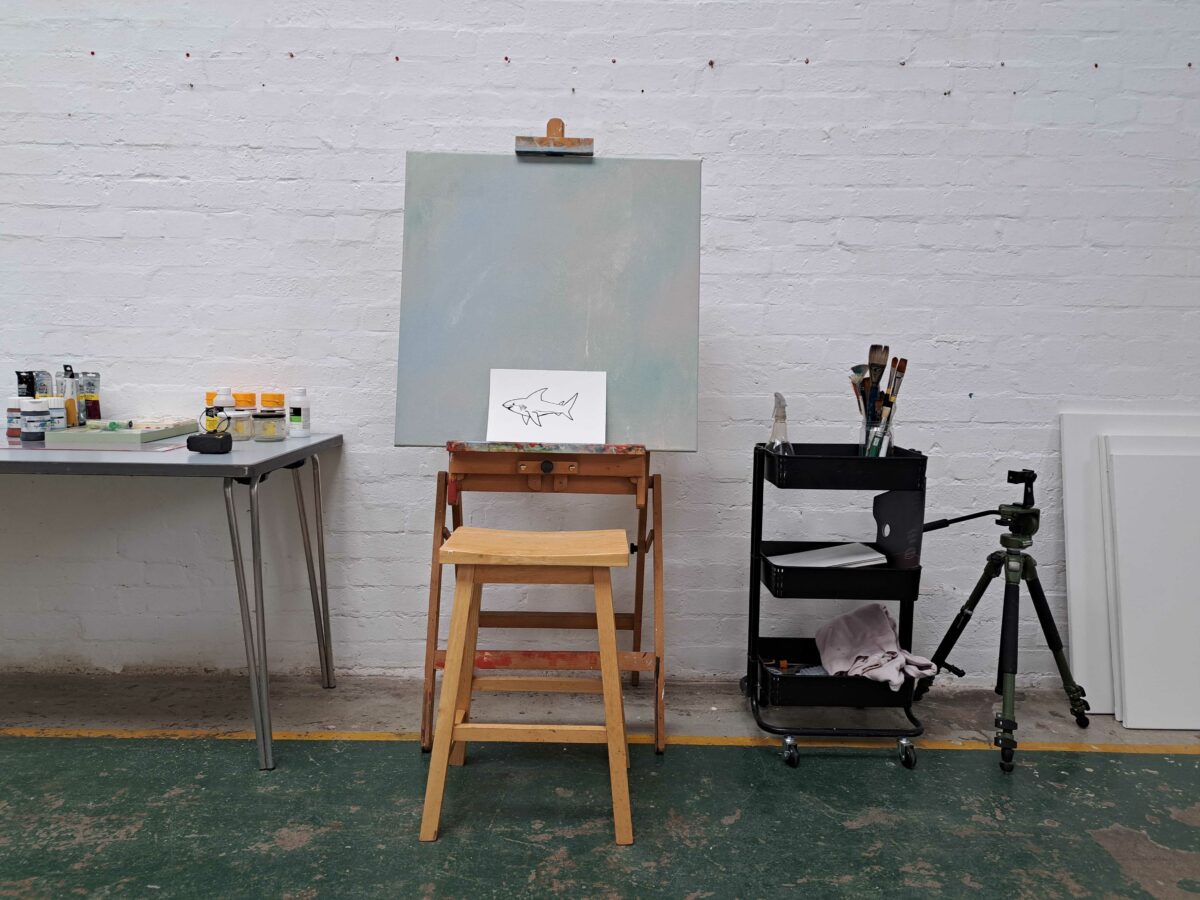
[742,444,926,768]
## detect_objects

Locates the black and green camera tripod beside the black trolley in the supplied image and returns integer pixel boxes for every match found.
[920,469,1090,772]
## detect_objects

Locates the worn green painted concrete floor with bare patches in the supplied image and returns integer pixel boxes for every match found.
[0,737,1200,898]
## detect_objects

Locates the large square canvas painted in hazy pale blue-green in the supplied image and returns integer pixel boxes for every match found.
[396,152,700,458]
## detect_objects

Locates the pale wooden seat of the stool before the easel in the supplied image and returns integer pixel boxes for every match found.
[438,526,629,569]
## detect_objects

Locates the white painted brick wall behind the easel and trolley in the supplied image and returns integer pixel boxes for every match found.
[0,0,1200,680]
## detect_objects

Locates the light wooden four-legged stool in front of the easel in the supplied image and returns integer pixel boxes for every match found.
[421,527,634,844]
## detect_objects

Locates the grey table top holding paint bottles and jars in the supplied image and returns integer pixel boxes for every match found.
[0,434,342,478]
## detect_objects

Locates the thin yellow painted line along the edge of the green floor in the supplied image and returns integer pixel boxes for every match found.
[0,726,1200,756]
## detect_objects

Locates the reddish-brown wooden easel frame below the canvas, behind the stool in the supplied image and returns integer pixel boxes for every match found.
[421,442,666,754]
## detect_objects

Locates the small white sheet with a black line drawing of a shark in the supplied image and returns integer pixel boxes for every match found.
[487,368,607,444]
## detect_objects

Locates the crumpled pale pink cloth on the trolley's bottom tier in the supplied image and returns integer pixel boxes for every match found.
[816,604,935,691]
